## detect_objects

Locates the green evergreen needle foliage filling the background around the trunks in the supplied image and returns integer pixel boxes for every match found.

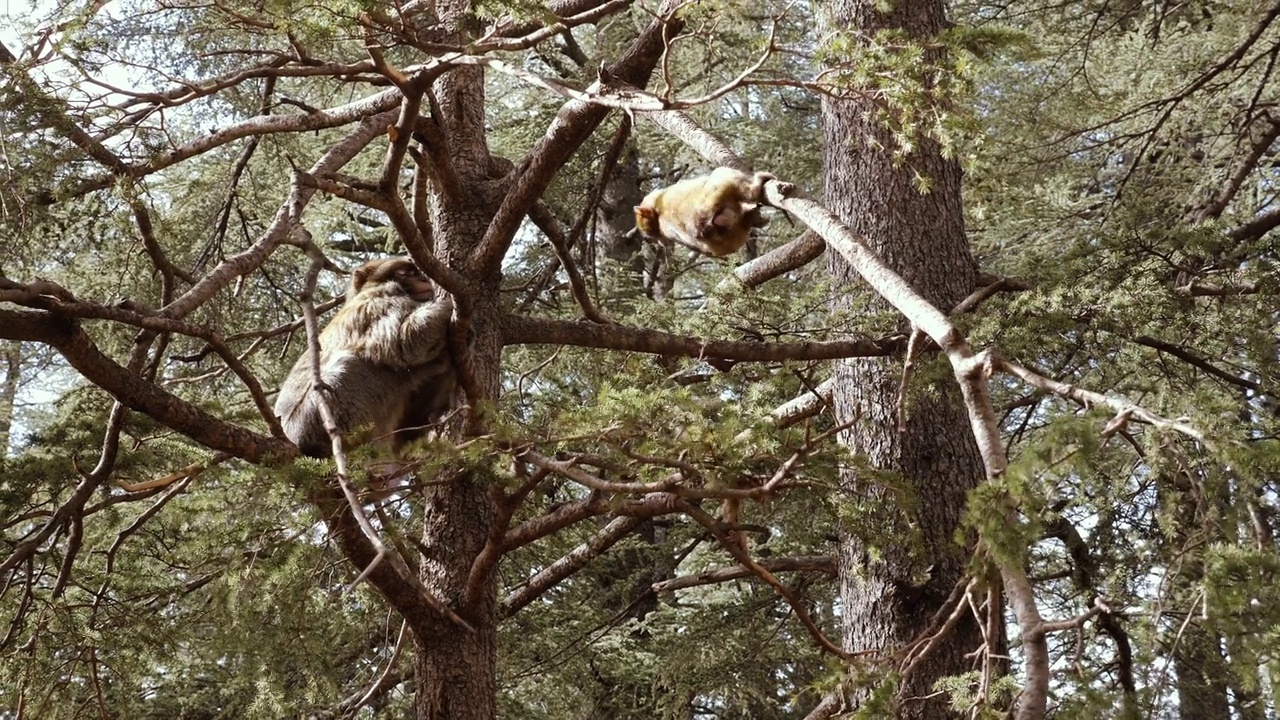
[0,0,1280,720]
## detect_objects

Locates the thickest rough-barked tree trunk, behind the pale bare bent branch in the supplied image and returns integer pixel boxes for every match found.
[823,0,983,719]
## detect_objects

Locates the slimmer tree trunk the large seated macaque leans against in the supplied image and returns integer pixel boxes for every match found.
[413,0,502,720]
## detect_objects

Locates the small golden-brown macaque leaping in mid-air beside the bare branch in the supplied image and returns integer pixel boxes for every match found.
[635,168,776,258]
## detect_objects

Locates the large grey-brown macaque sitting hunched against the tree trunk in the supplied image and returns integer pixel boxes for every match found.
[275,258,457,457]
